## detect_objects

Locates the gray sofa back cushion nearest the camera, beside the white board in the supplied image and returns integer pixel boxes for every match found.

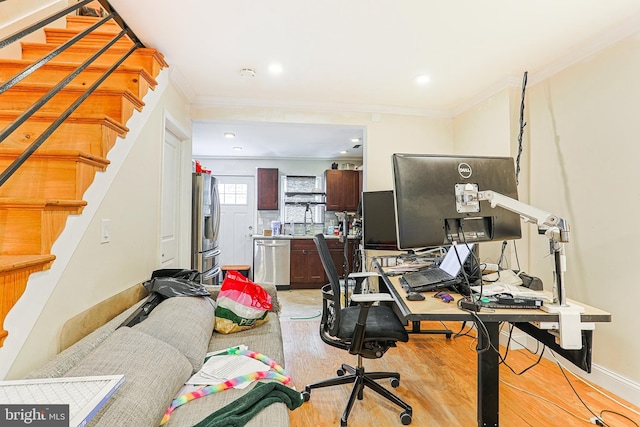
[66,327,192,427]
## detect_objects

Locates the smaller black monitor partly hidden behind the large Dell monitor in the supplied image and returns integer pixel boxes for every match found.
[362,190,398,251]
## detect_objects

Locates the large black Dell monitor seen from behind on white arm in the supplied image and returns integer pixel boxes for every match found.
[392,153,522,250]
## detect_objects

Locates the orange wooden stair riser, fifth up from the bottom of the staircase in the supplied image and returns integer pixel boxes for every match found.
[2,85,137,123]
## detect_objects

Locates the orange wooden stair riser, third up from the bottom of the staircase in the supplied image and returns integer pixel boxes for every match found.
[0,156,106,200]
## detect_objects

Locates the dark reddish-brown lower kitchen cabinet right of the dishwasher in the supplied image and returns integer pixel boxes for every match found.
[290,239,354,289]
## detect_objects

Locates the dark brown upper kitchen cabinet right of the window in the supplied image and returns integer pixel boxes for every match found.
[325,169,362,212]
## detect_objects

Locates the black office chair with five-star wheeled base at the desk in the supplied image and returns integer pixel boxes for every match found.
[302,234,413,426]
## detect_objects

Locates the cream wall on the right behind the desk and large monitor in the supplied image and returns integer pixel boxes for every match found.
[454,35,640,404]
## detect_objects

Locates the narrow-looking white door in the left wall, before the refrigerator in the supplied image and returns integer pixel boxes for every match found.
[160,129,182,268]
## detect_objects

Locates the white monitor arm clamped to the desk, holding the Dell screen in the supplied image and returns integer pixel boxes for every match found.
[477,190,569,307]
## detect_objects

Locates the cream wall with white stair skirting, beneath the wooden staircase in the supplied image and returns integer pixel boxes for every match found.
[0,71,191,378]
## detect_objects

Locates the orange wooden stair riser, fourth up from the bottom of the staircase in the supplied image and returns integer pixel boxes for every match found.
[0,119,126,158]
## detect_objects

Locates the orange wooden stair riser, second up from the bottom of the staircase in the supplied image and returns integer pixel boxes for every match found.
[0,207,81,255]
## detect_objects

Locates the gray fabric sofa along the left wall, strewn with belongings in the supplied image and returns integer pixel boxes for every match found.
[28,288,289,427]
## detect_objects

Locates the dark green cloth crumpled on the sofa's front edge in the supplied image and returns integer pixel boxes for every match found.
[194,382,303,427]
